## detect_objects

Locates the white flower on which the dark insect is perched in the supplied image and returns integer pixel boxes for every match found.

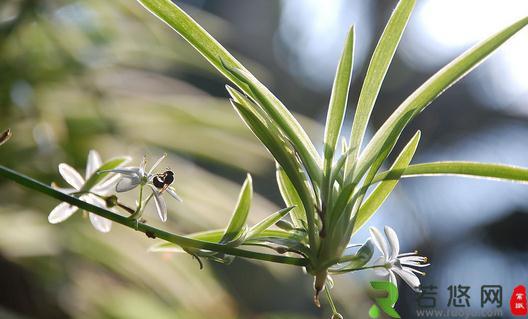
[109,154,182,222]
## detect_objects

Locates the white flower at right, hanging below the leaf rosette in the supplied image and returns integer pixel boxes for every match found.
[369,226,429,291]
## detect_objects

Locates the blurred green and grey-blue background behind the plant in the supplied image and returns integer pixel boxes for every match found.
[0,0,528,318]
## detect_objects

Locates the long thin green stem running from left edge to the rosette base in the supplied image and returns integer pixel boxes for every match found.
[0,165,309,266]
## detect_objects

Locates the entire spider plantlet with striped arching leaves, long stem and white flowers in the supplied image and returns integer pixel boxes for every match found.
[0,0,528,317]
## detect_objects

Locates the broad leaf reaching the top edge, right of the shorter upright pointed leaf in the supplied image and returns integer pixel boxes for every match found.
[347,0,415,174]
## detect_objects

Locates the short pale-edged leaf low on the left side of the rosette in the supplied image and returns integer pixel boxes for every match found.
[276,163,306,228]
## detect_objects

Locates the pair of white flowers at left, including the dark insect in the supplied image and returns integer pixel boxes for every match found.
[48,150,182,233]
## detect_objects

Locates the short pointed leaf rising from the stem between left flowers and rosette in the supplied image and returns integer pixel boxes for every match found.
[220,174,253,243]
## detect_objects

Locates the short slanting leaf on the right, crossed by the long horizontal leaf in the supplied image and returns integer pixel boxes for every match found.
[353,131,420,233]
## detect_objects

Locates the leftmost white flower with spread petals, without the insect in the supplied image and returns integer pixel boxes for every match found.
[48,150,125,233]
